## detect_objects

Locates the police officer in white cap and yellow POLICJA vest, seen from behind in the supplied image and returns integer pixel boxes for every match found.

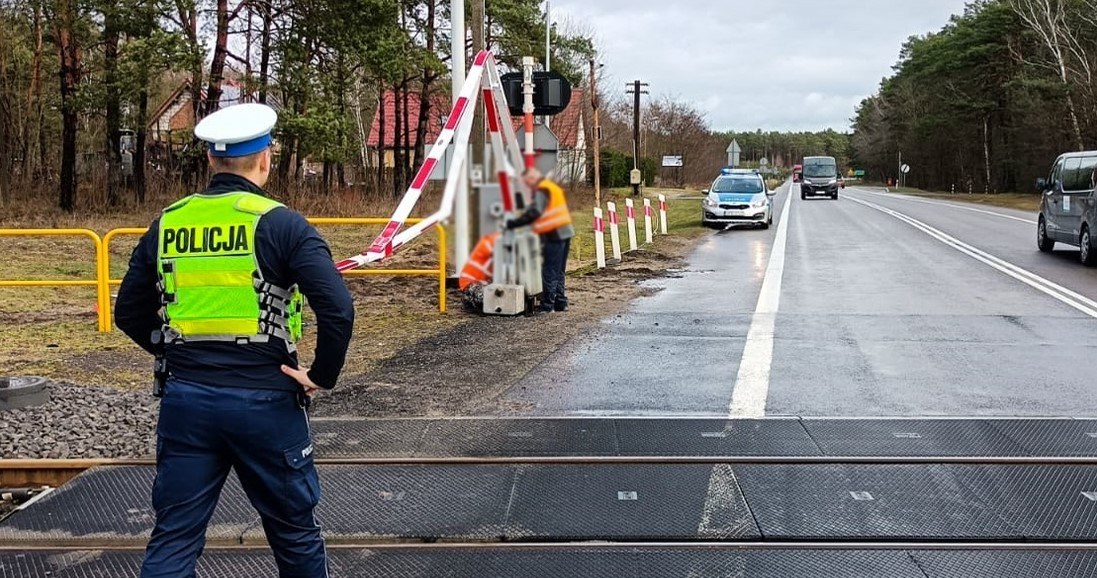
[115,104,354,578]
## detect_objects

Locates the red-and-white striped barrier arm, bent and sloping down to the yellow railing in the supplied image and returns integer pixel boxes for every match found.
[336,50,491,272]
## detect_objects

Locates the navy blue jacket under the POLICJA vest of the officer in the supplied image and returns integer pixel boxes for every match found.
[114,173,354,392]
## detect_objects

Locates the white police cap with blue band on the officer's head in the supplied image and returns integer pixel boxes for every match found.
[194,103,278,157]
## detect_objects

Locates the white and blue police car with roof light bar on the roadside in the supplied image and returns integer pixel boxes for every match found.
[701,169,773,229]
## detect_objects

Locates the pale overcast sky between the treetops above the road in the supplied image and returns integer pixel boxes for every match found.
[551,0,965,131]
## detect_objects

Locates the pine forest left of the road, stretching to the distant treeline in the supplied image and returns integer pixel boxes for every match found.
[0,0,851,212]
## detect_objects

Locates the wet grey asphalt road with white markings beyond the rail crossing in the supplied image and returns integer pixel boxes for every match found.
[508,186,1097,417]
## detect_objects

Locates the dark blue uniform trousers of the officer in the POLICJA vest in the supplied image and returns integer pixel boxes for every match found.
[140,379,328,578]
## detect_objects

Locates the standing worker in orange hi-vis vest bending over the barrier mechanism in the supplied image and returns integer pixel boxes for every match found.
[507,168,575,313]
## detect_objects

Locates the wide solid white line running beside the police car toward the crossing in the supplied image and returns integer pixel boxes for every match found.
[727,184,796,418]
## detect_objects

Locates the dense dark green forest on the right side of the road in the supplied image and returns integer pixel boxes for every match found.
[852,0,1097,193]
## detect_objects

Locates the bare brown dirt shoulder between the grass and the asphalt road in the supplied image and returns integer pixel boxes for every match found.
[313,231,700,417]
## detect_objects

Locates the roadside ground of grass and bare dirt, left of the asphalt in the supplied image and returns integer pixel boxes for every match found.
[0,191,704,416]
